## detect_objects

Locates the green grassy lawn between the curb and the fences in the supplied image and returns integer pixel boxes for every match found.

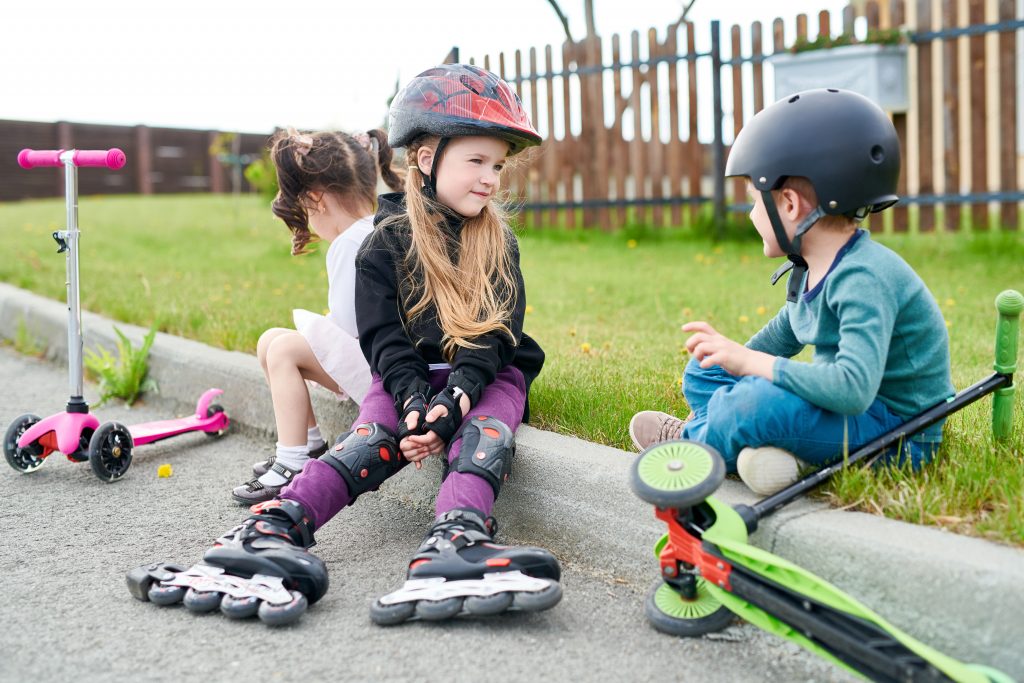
[0,196,1024,545]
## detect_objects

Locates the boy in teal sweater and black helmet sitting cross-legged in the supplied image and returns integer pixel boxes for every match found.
[630,89,953,495]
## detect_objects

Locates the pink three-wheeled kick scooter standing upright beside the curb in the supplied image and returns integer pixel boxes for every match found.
[3,148,228,481]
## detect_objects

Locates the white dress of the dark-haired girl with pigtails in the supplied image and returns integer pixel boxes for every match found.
[292,216,374,403]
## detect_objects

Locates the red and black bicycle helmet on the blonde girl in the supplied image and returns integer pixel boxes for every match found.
[388,65,541,156]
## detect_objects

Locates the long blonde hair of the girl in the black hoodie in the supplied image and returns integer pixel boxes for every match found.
[393,136,518,361]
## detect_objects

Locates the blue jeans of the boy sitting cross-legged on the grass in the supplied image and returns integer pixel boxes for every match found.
[682,359,938,472]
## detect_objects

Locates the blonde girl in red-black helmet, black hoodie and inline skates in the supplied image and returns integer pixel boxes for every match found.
[128,65,562,625]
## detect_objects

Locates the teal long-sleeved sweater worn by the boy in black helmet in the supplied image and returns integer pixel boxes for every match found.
[746,229,954,442]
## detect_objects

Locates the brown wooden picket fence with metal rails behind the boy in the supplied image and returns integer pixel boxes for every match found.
[469,0,1024,231]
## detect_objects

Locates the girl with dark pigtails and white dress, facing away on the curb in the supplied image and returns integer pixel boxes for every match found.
[231,129,401,505]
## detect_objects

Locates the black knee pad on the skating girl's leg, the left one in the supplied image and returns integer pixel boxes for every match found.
[319,422,409,501]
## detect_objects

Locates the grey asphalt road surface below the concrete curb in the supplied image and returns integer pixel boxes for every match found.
[0,348,854,683]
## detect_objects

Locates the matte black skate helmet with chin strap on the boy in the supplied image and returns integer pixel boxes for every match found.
[725,88,900,301]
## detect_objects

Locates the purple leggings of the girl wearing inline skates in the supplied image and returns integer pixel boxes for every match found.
[281,366,526,528]
